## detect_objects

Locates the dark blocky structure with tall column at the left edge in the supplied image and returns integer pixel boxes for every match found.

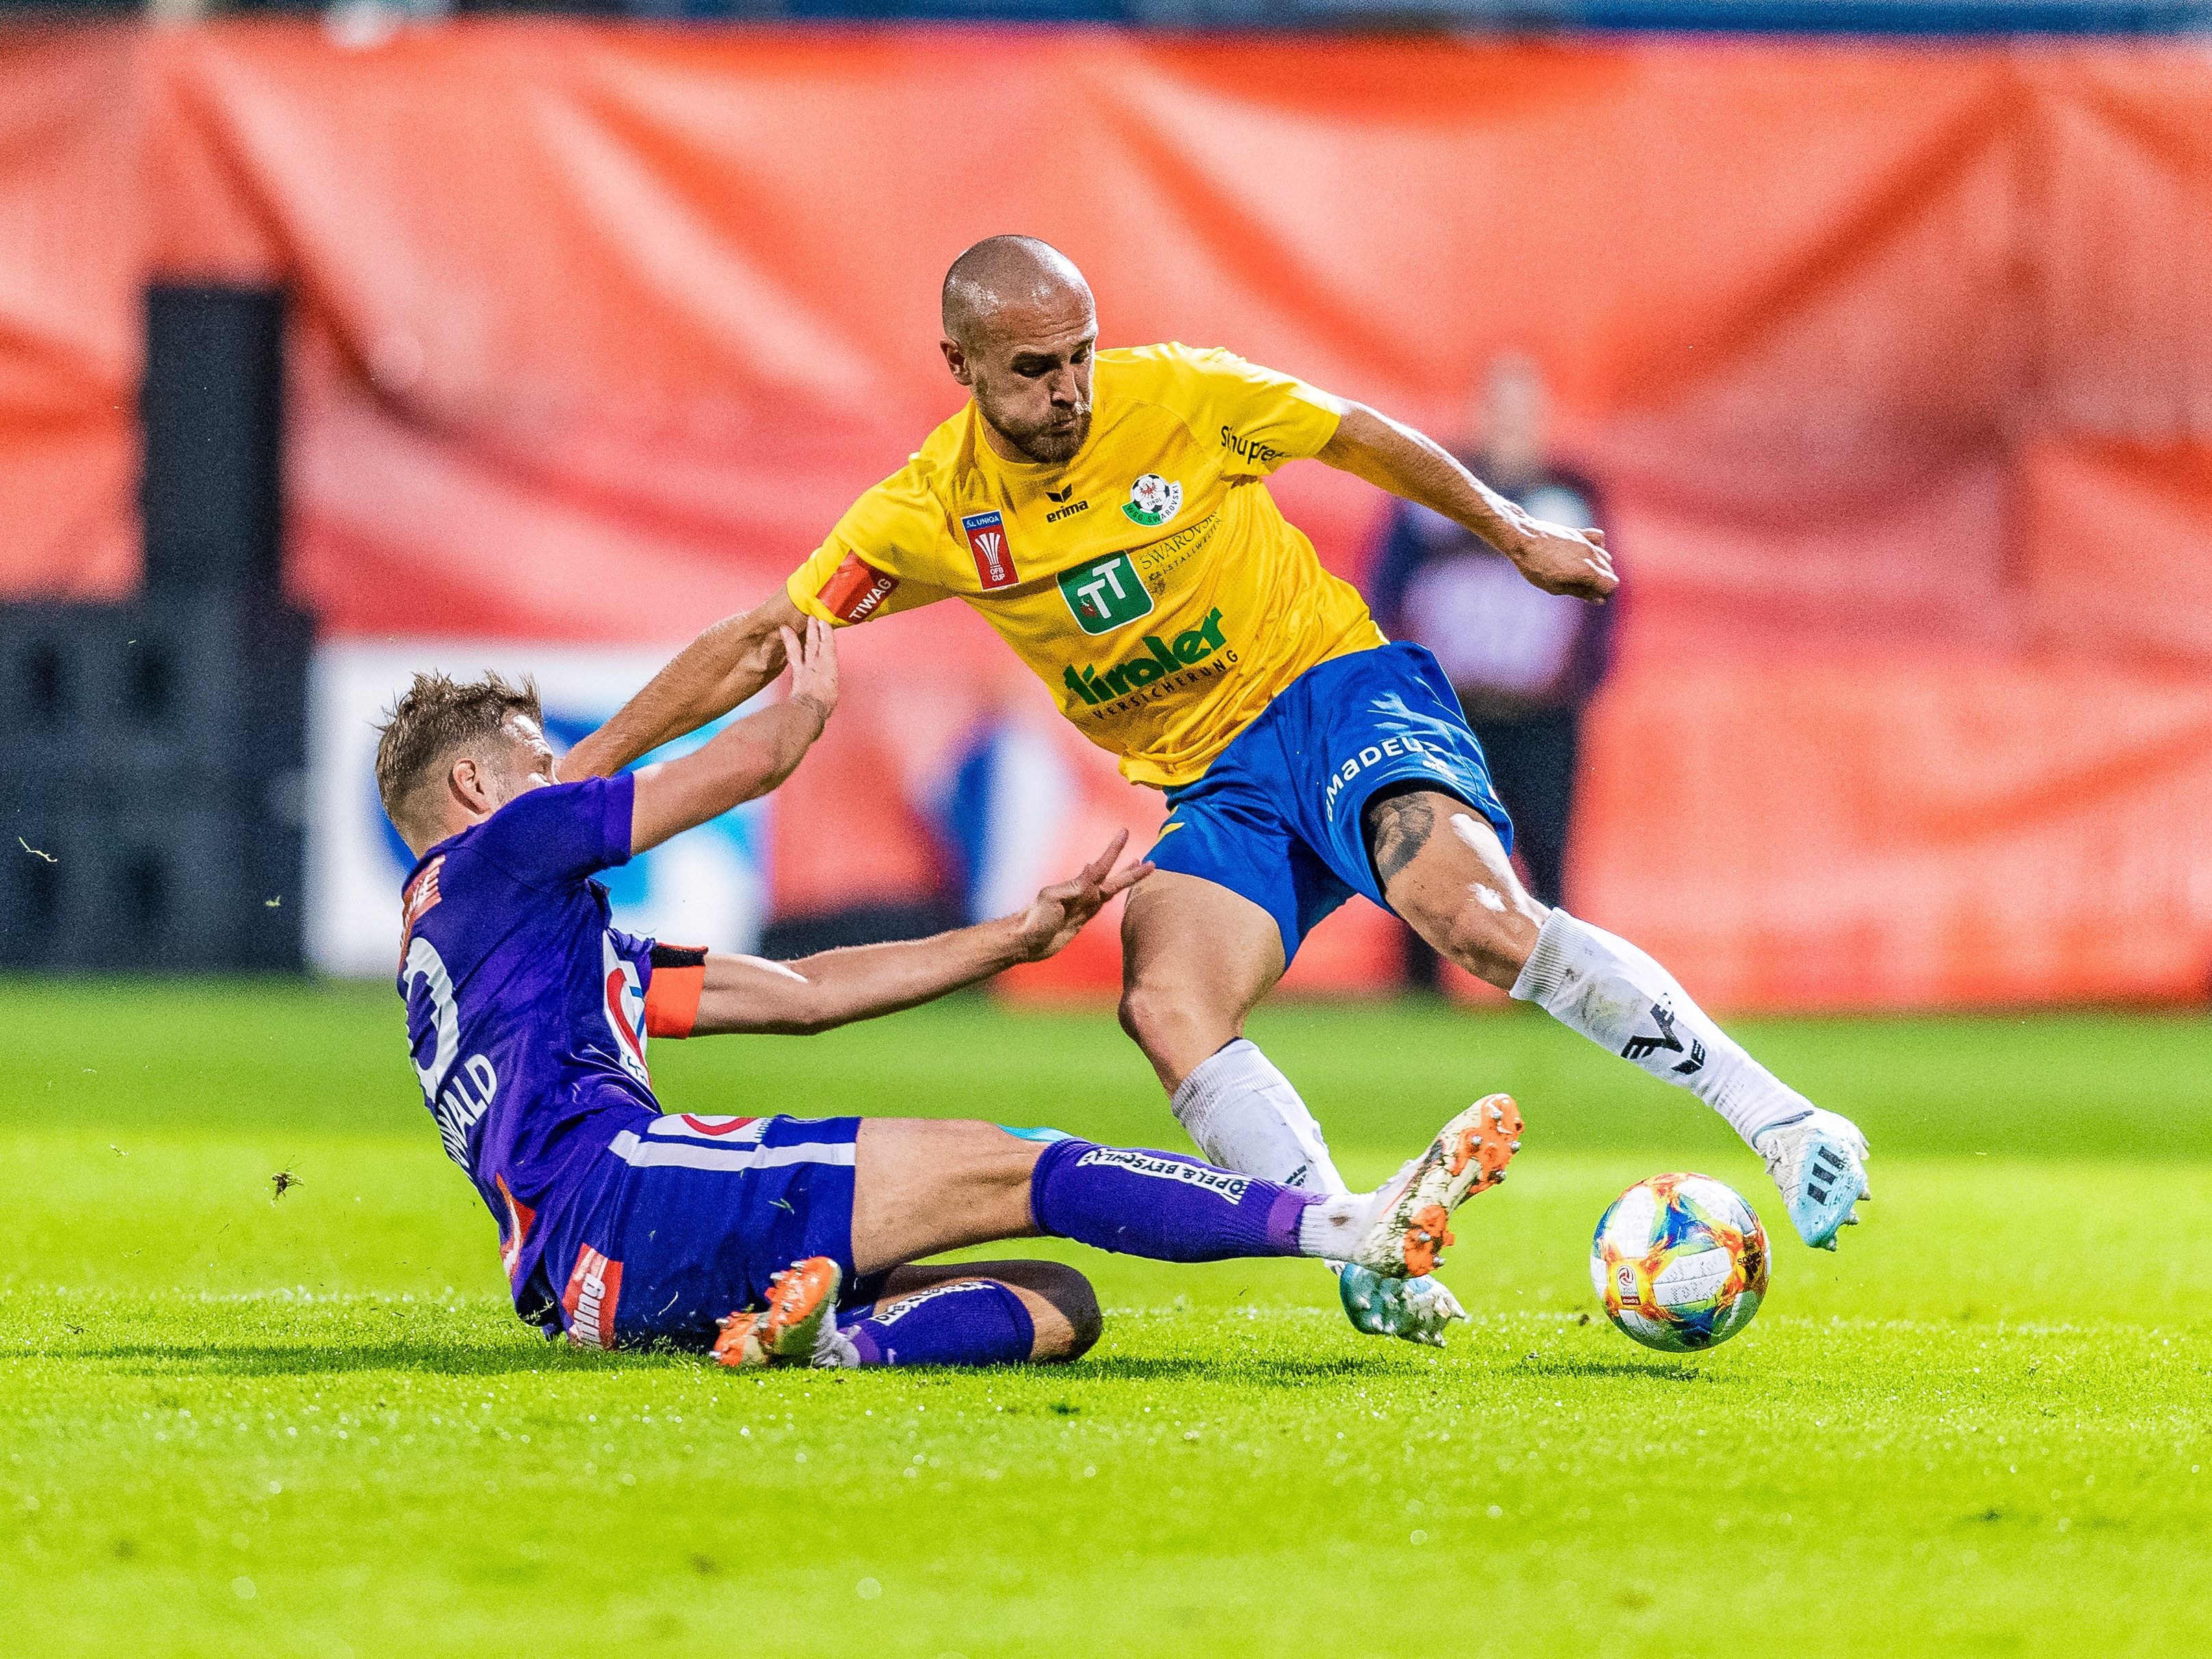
[0,288,314,971]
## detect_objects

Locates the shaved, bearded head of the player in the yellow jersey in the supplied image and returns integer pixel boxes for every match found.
[938,237,1099,466]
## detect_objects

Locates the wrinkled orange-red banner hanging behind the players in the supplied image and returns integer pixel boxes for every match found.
[0,25,2212,1004]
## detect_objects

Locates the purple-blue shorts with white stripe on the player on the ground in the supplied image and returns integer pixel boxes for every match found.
[544,1112,873,1349]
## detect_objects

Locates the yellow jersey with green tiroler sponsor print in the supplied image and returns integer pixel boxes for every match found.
[788,345,1382,788]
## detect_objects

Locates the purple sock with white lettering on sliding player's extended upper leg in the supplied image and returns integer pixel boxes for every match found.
[1028,1139,1323,1261]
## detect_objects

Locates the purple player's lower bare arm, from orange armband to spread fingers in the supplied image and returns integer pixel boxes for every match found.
[666,830,1152,1038]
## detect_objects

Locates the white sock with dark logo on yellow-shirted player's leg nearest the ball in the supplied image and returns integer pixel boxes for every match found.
[1513,909,1812,1141]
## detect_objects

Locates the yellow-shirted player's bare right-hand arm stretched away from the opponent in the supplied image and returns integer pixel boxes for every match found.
[1318,403,1619,599]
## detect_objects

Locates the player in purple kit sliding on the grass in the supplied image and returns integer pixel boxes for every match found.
[376,619,1519,1364]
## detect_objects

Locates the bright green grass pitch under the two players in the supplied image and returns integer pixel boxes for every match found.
[0,982,2212,1659]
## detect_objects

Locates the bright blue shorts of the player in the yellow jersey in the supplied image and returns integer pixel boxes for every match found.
[1146,642,1513,964]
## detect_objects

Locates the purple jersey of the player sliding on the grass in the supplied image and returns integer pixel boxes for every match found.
[398,774,659,1319]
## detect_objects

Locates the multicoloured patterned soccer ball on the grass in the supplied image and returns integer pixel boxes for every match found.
[1591,1175,1767,1354]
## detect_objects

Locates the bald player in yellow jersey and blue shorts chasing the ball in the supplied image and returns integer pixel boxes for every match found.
[562,237,1867,1343]
